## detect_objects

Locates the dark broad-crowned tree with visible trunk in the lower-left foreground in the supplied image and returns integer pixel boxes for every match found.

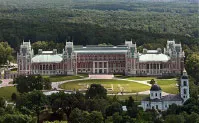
[16,90,48,123]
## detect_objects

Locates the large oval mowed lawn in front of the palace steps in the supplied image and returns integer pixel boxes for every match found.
[60,79,150,93]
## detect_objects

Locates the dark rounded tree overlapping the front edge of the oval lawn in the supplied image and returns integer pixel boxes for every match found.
[86,84,107,99]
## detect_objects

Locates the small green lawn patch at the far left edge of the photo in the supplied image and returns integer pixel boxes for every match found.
[0,87,18,100]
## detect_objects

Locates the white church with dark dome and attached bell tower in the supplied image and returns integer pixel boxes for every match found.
[141,71,190,110]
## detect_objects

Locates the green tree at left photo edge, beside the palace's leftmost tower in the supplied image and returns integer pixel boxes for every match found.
[0,42,13,65]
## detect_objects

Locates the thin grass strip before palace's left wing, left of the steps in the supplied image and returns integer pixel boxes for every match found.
[43,76,84,82]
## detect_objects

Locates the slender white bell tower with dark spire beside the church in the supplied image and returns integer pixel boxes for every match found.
[180,70,190,103]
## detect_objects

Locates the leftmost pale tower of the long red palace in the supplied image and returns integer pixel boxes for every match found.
[17,41,34,75]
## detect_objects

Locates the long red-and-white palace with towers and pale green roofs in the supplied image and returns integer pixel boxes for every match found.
[17,41,184,76]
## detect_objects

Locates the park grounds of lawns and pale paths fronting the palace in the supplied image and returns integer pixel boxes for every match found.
[0,74,178,101]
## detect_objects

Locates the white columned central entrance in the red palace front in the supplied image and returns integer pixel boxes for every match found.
[93,61,108,74]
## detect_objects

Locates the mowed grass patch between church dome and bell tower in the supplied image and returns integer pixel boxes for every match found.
[156,79,179,94]
